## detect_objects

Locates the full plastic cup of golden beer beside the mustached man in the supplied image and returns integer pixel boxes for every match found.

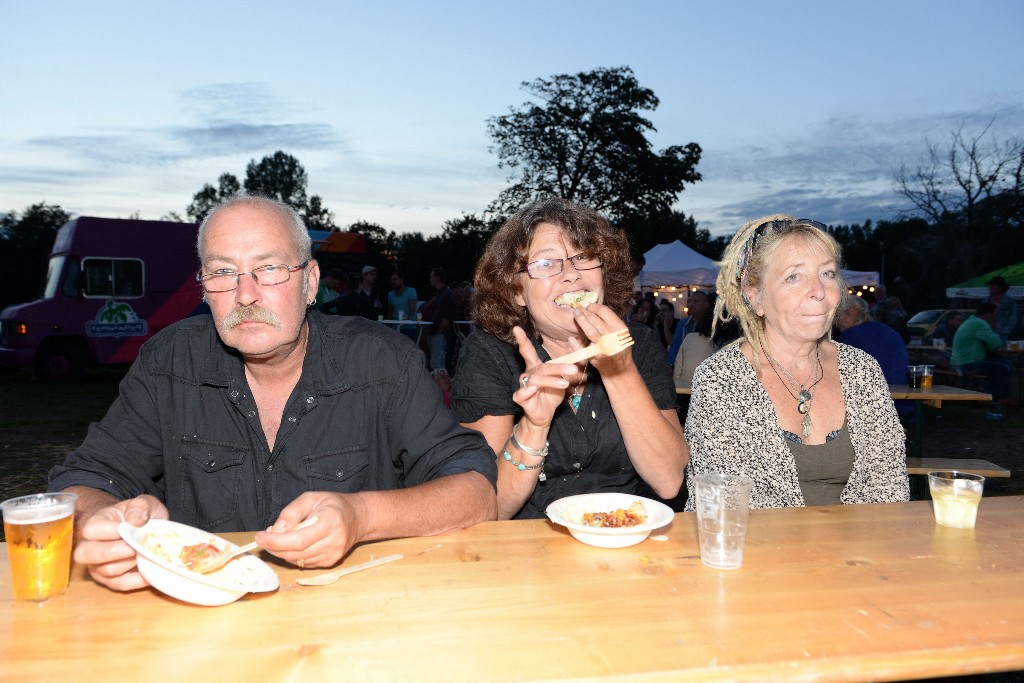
[0,494,78,602]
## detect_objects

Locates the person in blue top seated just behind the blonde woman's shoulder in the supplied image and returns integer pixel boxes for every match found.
[836,295,913,417]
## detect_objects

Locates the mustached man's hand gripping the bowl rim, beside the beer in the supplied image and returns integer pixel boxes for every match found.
[75,496,169,591]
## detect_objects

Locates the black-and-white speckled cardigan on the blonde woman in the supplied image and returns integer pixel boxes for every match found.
[686,343,910,510]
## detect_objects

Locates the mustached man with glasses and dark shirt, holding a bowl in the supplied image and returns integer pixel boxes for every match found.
[50,197,496,590]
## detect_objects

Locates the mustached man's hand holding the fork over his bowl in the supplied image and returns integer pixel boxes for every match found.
[255,492,367,568]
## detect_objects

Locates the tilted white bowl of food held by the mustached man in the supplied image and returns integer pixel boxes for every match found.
[118,519,281,606]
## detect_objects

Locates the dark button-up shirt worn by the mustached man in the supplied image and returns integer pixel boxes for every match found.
[50,310,497,531]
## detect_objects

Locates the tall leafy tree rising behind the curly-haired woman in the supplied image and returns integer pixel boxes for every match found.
[487,67,700,220]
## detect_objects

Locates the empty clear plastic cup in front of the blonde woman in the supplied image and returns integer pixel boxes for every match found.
[693,474,754,569]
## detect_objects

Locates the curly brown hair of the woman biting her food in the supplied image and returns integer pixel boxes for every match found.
[473,199,633,344]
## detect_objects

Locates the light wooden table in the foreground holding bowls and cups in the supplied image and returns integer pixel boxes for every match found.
[0,497,1024,681]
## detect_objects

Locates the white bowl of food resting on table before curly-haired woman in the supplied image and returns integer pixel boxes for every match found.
[546,494,676,548]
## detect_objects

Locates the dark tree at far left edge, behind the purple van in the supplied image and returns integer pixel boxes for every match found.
[0,203,71,308]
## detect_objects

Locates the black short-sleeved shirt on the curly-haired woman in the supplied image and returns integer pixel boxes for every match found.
[452,324,676,519]
